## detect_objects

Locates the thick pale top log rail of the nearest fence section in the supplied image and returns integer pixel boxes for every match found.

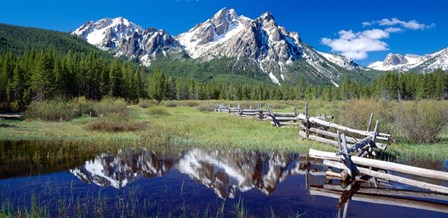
[309,149,448,181]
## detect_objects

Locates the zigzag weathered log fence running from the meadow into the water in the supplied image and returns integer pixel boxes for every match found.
[216,104,448,214]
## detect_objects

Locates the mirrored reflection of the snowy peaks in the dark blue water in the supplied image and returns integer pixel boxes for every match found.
[70,149,306,199]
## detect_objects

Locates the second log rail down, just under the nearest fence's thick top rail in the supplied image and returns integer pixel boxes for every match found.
[324,160,448,194]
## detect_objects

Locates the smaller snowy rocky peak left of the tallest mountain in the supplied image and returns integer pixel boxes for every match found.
[72,17,185,66]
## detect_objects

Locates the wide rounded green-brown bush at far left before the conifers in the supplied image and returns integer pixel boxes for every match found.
[25,100,82,121]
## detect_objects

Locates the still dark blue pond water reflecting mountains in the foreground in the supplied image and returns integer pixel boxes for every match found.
[0,142,448,217]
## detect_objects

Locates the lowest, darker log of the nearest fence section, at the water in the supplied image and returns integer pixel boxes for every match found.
[309,187,448,213]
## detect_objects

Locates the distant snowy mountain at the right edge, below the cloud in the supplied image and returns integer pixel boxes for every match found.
[368,48,448,73]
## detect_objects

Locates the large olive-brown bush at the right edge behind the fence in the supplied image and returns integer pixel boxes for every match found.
[394,101,448,143]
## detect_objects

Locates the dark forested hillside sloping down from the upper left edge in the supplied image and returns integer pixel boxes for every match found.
[0,24,110,56]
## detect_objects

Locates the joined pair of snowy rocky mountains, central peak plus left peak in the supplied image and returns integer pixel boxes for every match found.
[72,8,367,85]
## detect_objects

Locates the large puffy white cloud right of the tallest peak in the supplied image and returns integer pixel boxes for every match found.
[321,29,390,60]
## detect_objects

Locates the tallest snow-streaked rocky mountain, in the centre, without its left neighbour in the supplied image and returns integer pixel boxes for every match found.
[177,8,361,84]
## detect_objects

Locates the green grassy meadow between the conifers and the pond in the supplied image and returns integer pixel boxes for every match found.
[0,101,448,160]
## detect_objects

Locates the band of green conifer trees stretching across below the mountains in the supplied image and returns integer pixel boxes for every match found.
[0,48,448,110]
